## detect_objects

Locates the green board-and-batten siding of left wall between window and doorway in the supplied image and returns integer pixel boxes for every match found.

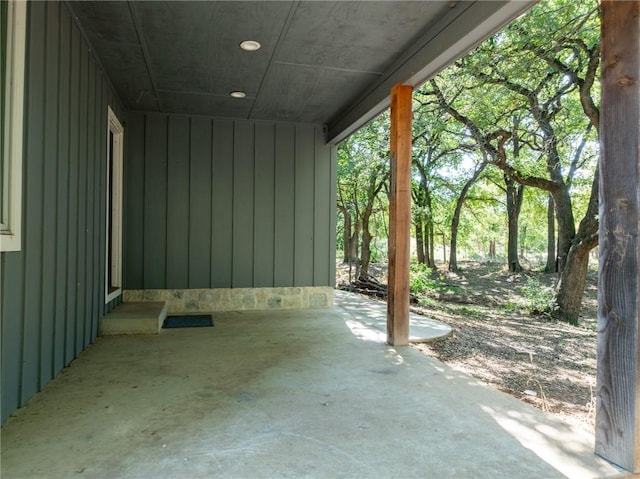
[0,2,123,422]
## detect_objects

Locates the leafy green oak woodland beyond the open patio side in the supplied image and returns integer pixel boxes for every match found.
[337,0,600,324]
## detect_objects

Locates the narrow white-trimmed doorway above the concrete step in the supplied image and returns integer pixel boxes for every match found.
[105,107,124,304]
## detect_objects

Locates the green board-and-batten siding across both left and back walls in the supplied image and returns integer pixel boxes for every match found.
[0,2,336,422]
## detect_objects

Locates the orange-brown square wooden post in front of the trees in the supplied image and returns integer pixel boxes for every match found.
[387,84,413,346]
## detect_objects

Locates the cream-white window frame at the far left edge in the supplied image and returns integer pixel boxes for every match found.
[0,1,27,251]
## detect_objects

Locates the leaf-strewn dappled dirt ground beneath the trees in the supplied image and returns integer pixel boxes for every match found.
[337,262,597,432]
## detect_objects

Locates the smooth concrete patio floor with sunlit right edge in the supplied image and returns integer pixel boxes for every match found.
[1,295,621,479]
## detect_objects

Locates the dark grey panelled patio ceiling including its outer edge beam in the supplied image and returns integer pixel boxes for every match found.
[67,1,532,140]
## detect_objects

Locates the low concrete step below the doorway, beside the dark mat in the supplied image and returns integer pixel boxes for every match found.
[100,301,167,336]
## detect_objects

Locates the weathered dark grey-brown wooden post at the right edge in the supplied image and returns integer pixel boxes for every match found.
[596,0,640,472]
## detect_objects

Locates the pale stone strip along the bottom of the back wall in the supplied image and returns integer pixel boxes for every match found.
[123,286,333,313]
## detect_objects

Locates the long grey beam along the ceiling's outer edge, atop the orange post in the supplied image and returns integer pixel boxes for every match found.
[328,0,537,143]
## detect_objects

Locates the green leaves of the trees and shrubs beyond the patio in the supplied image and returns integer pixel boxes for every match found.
[338,0,600,313]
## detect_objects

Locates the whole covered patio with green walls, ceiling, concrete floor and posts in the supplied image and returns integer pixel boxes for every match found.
[0,0,640,478]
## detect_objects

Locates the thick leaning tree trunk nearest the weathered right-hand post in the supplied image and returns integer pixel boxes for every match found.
[554,168,600,324]
